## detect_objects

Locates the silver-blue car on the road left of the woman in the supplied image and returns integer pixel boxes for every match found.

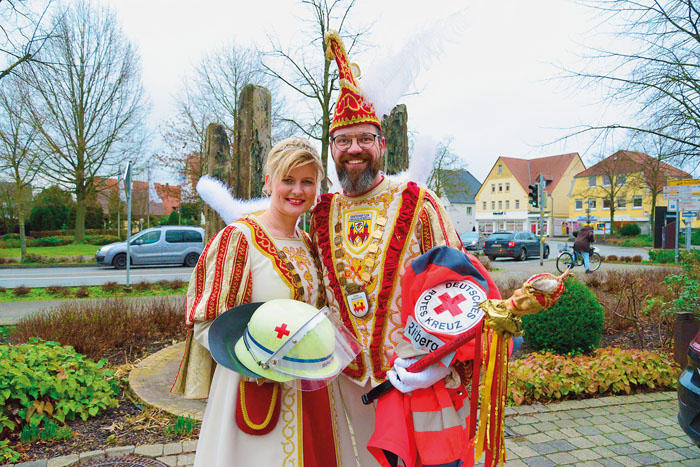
[95,225,204,269]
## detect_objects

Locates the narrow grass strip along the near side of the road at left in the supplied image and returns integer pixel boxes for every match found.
[0,282,187,303]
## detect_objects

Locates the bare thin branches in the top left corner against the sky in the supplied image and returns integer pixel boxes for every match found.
[0,0,53,79]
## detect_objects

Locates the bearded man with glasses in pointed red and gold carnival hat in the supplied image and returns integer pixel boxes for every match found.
[311,32,500,467]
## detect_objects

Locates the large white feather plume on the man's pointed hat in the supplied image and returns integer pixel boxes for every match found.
[359,10,466,119]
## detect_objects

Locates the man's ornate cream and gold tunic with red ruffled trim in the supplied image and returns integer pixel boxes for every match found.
[310,178,462,385]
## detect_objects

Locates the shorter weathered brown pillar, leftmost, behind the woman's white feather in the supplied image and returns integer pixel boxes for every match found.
[204,123,231,241]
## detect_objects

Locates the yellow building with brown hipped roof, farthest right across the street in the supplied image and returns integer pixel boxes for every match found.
[569,150,700,234]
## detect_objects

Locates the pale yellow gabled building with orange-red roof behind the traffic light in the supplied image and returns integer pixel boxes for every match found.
[475,152,585,235]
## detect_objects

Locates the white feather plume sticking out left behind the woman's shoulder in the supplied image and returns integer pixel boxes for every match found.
[197,175,270,224]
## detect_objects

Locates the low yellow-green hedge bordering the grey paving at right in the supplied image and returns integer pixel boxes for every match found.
[508,348,681,405]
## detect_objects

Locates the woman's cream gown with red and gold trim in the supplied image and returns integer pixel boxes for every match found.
[172,215,357,467]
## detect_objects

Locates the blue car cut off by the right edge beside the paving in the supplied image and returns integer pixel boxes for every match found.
[678,333,700,446]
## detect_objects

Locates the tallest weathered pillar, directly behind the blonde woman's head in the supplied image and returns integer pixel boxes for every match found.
[232,84,272,199]
